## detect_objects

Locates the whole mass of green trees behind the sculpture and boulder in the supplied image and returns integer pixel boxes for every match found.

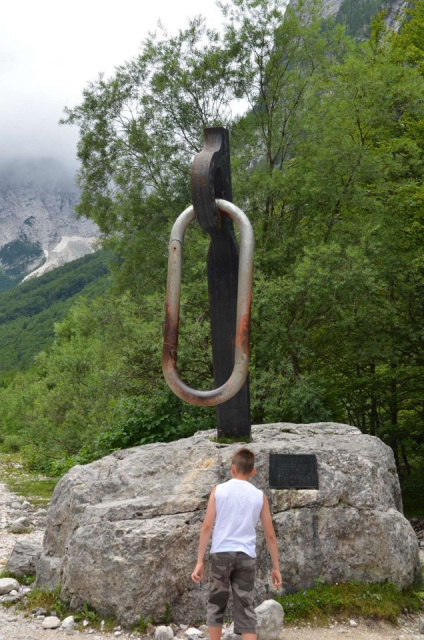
[0,0,424,510]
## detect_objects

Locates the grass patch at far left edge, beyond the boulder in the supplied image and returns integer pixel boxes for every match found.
[0,454,59,507]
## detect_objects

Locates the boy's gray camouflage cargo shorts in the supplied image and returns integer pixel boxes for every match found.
[206,551,256,635]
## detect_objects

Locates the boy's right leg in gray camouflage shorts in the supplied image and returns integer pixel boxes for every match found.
[231,552,256,640]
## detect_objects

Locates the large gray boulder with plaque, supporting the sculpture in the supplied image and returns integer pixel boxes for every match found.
[36,423,420,625]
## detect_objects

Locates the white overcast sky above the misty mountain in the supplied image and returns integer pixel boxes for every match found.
[0,0,221,168]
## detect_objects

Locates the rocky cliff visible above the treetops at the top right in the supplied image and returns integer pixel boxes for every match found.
[289,0,408,39]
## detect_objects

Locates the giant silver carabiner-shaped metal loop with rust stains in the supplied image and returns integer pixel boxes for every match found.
[162,200,254,406]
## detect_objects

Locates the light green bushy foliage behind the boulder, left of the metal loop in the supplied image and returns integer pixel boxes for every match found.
[0,295,217,471]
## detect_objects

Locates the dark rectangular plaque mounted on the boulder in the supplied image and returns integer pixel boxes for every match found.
[269,453,318,489]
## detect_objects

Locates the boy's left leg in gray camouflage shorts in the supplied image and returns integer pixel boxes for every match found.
[206,552,235,640]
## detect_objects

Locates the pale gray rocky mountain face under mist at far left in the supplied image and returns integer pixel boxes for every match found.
[0,158,98,280]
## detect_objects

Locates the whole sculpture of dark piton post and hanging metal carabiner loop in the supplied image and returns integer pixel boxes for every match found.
[163,127,254,438]
